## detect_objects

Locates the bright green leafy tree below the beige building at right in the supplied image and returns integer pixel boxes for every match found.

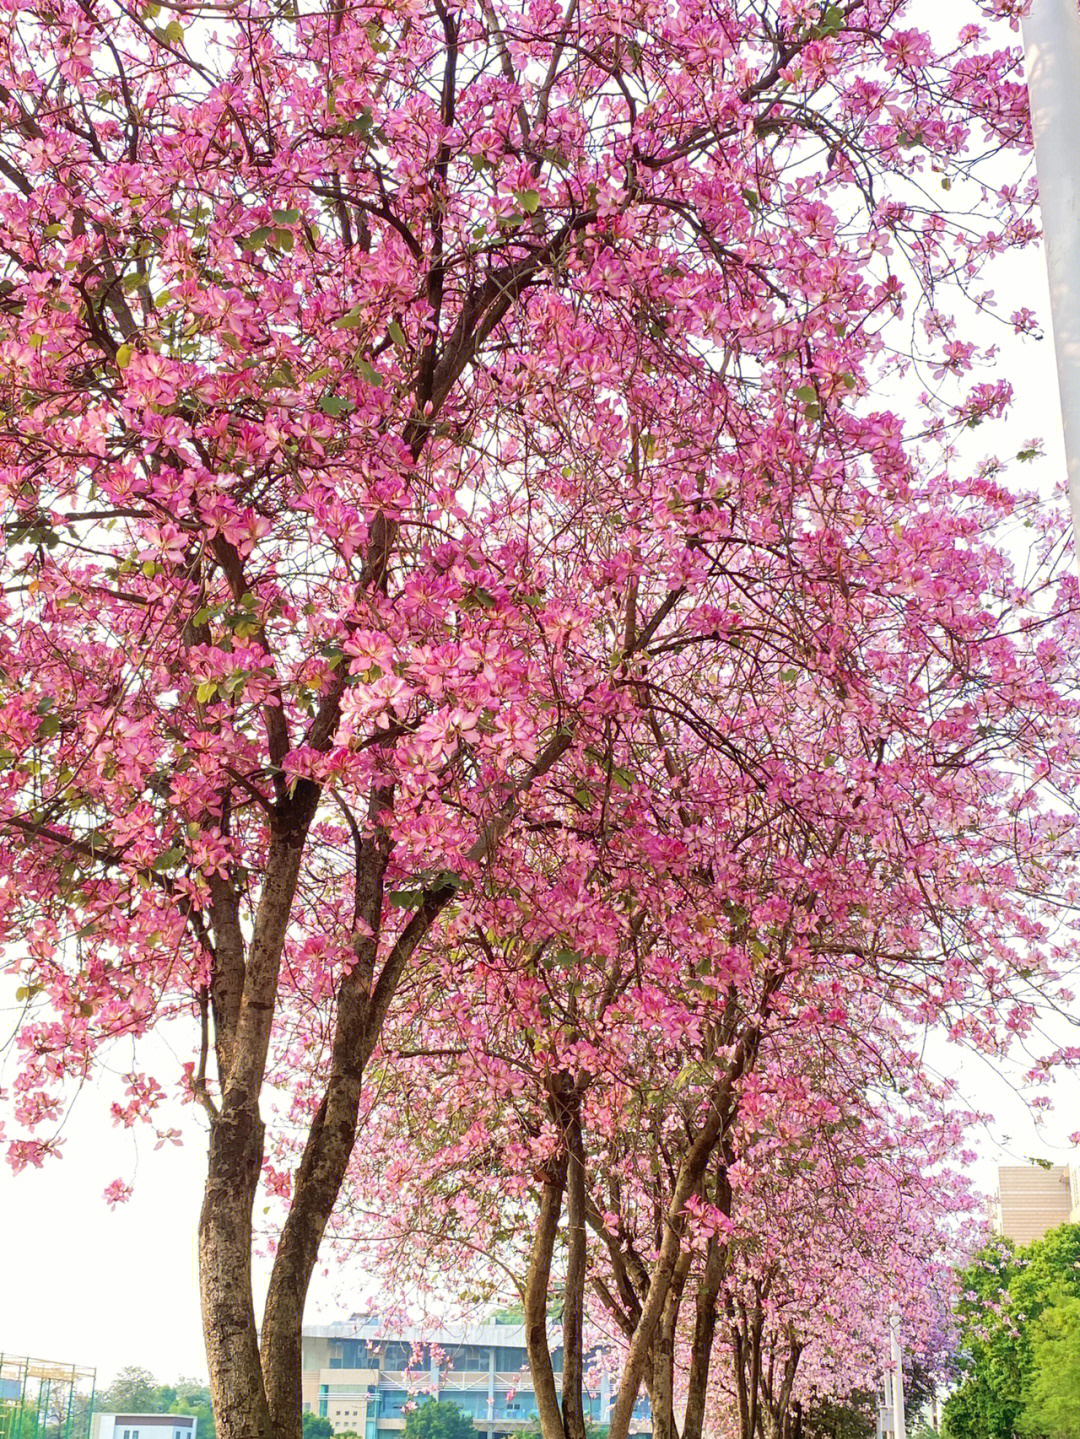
[942,1225,1080,1439]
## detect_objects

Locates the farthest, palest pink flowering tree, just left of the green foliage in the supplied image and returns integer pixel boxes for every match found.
[718,1093,984,1439]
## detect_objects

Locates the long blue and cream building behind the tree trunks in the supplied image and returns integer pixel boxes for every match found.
[301,1314,651,1439]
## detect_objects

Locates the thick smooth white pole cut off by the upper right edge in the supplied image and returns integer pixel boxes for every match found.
[1024,0,1080,550]
